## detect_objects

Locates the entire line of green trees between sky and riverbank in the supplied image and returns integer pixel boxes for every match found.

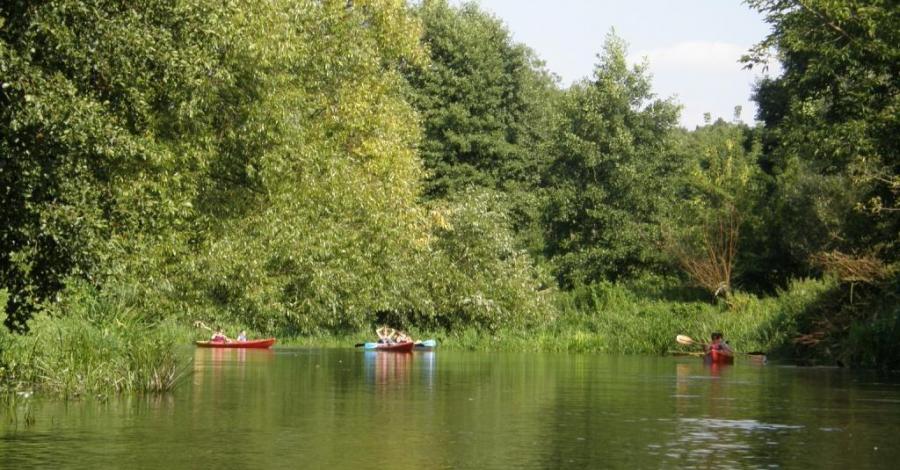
[0,0,900,392]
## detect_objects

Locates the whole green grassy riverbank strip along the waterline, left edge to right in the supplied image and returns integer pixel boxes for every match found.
[0,274,896,398]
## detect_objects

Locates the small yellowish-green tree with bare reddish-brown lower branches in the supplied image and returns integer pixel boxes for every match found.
[663,120,772,296]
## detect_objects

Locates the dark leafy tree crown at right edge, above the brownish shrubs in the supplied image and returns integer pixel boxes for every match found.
[746,0,900,266]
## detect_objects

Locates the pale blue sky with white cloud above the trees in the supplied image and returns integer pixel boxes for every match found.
[451,0,778,129]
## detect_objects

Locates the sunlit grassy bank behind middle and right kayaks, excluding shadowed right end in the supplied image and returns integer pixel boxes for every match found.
[272,280,835,354]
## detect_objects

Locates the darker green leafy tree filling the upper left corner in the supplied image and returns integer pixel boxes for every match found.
[0,1,234,328]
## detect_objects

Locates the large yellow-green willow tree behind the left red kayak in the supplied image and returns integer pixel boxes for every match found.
[181,1,429,331]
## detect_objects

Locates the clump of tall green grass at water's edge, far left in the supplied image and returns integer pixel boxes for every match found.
[0,282,187,398]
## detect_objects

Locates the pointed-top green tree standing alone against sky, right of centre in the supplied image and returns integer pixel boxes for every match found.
[545,34,680,286]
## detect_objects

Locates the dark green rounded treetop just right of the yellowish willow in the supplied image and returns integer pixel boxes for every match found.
[406,0,555,198]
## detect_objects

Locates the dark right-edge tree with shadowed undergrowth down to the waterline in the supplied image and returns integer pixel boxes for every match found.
[747,0,900,367]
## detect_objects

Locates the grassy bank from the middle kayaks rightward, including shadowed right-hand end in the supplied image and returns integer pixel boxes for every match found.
[279,278,900,370]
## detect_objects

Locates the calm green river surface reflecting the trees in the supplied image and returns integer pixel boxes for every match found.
[0,348,900,469]
